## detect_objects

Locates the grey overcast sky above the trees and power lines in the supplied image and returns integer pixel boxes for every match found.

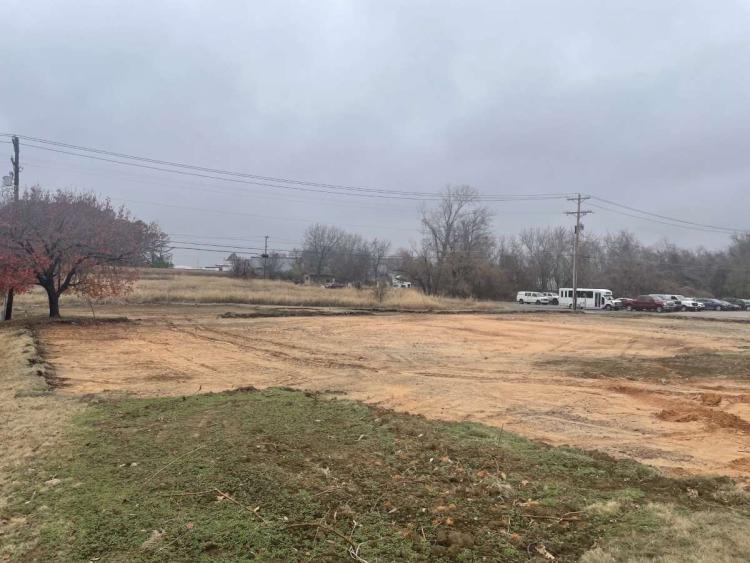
[0,0,750,265]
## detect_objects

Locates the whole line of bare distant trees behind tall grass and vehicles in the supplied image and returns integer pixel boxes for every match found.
[225,186,750,299]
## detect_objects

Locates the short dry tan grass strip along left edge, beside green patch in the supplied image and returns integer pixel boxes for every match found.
[0,329,80,559]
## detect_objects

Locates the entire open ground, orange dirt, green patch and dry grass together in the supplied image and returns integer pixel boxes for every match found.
[0,272,750,563]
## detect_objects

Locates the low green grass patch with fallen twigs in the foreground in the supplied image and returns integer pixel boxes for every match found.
[5,389,748,562]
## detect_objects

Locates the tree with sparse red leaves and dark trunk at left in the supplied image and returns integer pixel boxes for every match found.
[0,188,164,318]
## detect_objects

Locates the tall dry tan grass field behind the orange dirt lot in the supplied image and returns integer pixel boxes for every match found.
[18,270,500,311]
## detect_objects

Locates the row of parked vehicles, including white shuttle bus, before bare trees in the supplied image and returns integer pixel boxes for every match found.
[516,288,750,313]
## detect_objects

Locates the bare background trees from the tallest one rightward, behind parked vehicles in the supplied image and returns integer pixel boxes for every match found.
[400,186,750,299]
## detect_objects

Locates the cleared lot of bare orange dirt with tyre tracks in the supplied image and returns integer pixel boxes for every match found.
[38,308,750,481]
